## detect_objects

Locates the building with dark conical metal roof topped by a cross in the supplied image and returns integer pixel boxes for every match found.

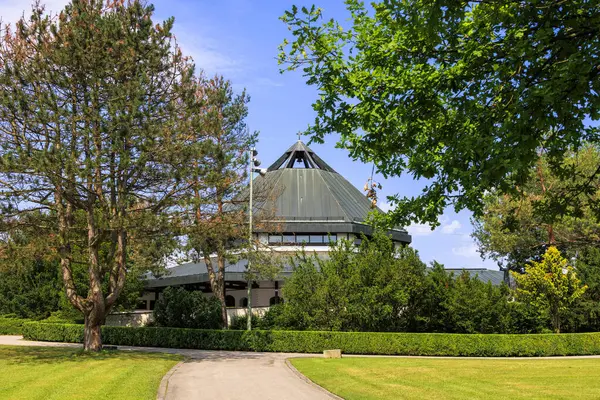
[140,140,411,309]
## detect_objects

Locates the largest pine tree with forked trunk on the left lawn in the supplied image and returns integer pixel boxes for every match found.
[0,0,195,350]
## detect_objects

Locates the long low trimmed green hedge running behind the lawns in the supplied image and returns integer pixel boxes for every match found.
[23,322,600,357]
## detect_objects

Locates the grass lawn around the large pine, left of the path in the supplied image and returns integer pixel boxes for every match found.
[0,346,181,400]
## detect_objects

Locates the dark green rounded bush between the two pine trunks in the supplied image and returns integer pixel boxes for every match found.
[154,287,222,329]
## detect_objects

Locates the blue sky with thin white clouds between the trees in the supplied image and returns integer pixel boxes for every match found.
[0,0,497,269]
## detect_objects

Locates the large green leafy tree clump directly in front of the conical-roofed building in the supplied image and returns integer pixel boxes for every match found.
[275,233,425,331]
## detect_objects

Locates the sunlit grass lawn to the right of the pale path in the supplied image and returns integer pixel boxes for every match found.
[291,357,600,400]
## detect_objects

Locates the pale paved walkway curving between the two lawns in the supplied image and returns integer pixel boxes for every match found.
[0,336,337,400]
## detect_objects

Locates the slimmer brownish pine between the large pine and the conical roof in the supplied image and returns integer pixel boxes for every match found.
[184,77,256,327]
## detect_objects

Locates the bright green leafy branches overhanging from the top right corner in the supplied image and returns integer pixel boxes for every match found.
[280,0,600,224]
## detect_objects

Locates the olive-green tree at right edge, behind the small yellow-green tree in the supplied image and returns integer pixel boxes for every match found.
[473,144,600,272]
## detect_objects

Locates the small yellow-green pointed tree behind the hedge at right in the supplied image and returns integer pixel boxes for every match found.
[512,246,587,333]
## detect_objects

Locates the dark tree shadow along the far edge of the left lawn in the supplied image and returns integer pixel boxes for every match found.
[0,346,181,365]
